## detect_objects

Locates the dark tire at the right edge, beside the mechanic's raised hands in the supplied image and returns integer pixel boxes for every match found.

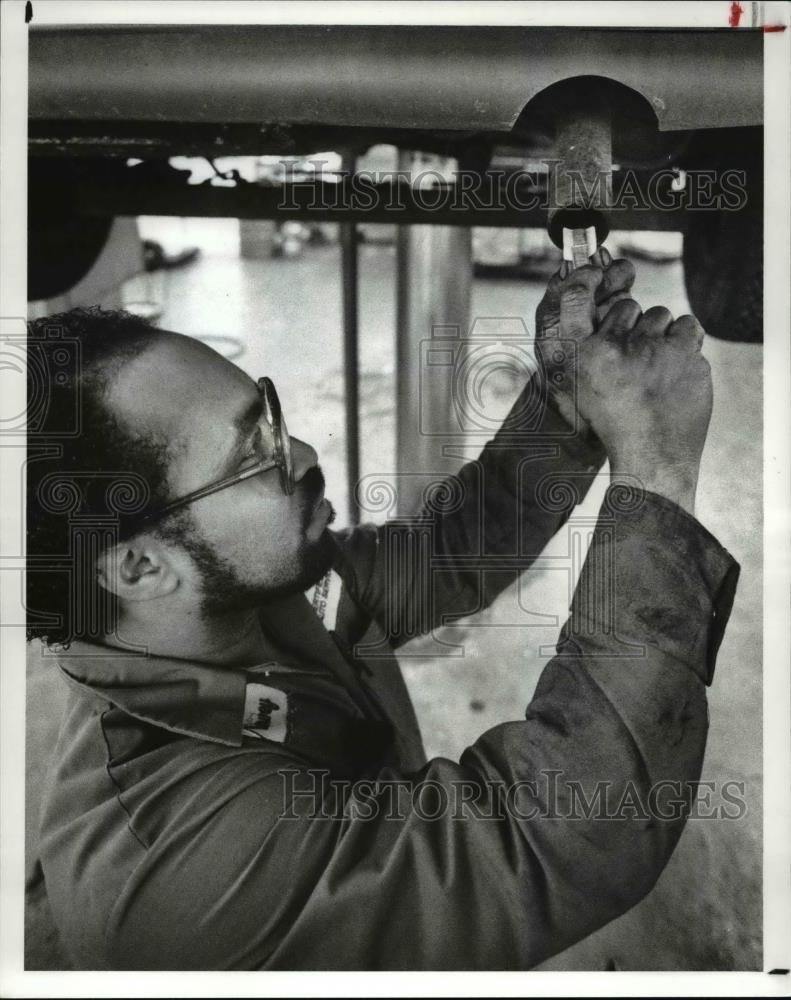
[684,201,764,344]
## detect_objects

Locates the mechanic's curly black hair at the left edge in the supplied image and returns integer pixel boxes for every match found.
[25,307,187,646]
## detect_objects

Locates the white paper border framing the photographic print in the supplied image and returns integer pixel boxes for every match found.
[0,0,791,997]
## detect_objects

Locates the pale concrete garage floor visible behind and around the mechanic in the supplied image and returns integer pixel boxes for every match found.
[28,220,764,970]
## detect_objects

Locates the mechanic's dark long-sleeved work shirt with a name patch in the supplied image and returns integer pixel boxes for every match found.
[35,376,738,969]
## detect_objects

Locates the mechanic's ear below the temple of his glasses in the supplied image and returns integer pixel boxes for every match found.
[96,536,181,601]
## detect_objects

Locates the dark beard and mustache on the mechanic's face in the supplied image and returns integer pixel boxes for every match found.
[171,466,337,618]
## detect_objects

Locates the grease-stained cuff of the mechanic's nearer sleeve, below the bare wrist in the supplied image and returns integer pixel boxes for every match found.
[571,485,740,685]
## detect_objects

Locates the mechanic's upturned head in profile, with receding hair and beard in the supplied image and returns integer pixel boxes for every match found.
[28,310,332,642]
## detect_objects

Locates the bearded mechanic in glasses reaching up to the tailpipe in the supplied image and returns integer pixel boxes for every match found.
[28,252,738,969]
